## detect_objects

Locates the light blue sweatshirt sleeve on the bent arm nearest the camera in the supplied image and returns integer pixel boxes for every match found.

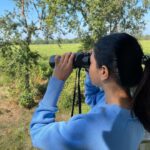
[30,77,86,150]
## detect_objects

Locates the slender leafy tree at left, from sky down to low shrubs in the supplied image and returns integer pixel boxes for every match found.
[0,0,51,108]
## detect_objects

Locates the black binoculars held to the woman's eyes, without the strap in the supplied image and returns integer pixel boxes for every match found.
[49,53,91,69]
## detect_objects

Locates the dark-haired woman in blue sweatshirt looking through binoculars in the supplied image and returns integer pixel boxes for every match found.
[30,33,150,150]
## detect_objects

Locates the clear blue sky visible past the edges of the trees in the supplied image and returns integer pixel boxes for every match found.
[0,0,150,38]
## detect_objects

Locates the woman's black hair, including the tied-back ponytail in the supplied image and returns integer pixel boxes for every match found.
[94,33,150,132]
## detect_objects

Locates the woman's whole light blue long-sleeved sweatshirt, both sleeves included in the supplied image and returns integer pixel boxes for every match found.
[30,74,144,150]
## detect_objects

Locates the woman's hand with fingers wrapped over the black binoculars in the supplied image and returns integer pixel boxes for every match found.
[53,53,75,81]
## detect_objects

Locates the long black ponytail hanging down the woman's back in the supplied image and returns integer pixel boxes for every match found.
[133,56,150,132]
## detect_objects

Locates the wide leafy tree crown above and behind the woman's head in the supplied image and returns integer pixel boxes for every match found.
[46,0,150,48]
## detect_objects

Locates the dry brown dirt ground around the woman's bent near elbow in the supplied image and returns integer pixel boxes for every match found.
[0,86,70,150]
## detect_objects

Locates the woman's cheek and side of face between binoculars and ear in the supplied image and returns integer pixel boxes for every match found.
[89,51,99,86]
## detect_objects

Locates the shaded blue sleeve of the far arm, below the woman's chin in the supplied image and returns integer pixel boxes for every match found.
[84,72,104,107]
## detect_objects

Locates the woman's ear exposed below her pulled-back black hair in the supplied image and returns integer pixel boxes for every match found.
[98,65,109,81]
